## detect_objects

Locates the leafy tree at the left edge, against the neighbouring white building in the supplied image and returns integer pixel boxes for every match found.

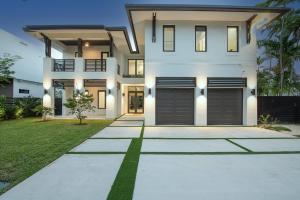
[0,54,21,87]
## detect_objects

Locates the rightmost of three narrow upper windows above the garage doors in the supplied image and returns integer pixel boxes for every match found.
[227,26,239,52]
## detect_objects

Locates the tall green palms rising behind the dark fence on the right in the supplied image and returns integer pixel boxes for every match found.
[257,0,300,95]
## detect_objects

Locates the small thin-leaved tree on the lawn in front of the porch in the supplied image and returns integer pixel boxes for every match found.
[64,92,95,124]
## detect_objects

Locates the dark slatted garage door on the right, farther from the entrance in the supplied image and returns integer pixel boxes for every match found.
[207,88,243,125]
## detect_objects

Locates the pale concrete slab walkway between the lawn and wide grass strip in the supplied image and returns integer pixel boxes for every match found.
[0,116,143,200]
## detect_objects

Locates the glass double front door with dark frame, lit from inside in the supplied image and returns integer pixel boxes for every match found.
[128,91,144,113]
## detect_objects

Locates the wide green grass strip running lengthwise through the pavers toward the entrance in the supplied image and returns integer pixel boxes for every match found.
[107,125,144,200]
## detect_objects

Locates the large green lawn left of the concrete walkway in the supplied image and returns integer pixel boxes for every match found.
[0,118,111,194]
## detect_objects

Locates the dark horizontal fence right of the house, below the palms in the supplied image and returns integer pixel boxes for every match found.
[257,96,300,123]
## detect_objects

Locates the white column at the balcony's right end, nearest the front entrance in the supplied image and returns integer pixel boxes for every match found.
[106,57,118,119]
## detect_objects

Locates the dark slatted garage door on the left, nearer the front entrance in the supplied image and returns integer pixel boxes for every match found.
[156,88,194,125]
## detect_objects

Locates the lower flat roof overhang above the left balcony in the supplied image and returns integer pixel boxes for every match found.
[23,25,134,53]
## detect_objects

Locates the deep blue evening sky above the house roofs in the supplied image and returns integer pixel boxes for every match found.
[0,0,300,73]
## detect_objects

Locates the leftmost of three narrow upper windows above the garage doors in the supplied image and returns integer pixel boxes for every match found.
[163,25,175,52]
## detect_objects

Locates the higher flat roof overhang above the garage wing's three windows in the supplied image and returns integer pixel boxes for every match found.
[125,4,290,52]
